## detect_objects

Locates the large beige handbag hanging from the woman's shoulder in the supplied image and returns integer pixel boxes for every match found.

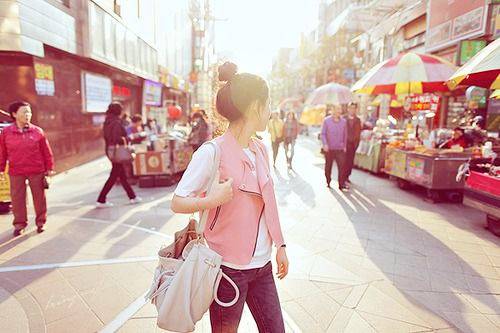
[147,141,240,332]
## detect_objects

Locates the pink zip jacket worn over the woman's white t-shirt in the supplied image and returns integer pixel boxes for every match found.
[204,132,284,265]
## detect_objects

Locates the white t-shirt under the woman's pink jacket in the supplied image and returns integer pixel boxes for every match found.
[174,145,272,270]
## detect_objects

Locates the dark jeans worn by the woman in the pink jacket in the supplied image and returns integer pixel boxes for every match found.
[210,262,285,333]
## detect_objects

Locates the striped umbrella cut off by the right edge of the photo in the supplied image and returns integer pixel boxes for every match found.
[448,39,500,89]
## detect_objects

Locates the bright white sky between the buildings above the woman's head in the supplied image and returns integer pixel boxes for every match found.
[215,0,319,76]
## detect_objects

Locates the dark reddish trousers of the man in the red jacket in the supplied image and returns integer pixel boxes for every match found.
[9,173,47,230]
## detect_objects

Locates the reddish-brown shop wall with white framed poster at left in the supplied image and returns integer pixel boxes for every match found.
[0,45,148,171]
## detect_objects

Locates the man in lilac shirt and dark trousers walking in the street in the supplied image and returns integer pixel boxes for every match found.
[321,105,348,191]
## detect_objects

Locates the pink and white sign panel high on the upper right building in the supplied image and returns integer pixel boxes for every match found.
[426,0,488,52]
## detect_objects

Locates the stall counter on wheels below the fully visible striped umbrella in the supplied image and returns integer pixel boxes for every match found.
[384,148,471,201]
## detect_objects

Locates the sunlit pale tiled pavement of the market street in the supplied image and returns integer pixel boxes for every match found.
[0,134,500,332]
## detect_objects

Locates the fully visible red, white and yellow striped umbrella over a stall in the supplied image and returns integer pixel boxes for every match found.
[351,52,456,95]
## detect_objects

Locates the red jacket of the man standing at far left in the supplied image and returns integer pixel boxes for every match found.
[0,124,54,176]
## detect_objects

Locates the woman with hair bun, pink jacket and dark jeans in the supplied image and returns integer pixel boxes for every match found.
[172,62,288,333]
